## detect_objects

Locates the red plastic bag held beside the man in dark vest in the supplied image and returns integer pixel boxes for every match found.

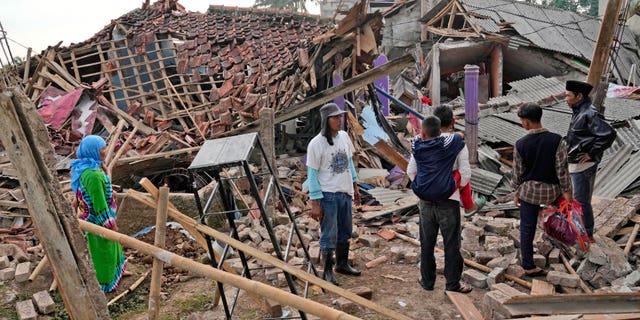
[542,198,589,252]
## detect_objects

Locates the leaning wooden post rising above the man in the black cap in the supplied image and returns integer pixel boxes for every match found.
[587,0,622,113]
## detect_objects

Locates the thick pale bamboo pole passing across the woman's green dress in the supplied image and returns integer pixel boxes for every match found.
[78,220,359,320]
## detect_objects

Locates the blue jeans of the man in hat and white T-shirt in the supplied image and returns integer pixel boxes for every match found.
[319,192,353,250]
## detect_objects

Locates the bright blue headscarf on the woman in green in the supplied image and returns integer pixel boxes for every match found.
[71,136,107,192]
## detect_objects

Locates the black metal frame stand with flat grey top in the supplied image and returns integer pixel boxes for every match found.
[189,133,318,320]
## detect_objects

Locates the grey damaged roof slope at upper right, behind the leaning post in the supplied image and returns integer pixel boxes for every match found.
[421,0,640,84]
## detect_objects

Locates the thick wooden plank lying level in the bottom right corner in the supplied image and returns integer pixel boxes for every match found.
[502,293,640,316]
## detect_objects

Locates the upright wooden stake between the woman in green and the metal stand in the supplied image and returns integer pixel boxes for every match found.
[148,186,169,320]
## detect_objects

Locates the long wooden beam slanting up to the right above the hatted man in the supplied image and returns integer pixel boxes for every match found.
[275,55,415,123]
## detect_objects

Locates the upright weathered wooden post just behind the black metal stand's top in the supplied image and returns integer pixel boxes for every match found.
[258,108,278,217]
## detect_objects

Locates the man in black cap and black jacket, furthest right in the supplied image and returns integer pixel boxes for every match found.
[565,80,616,241]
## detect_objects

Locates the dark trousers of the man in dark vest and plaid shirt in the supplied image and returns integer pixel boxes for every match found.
[520,200,540,270]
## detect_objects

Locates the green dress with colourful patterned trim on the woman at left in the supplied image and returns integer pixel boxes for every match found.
[76,169,126,292]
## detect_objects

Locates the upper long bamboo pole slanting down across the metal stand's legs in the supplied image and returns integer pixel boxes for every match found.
[132,188,410,320]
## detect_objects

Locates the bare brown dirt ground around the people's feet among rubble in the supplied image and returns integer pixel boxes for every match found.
[0,222,508,320]
